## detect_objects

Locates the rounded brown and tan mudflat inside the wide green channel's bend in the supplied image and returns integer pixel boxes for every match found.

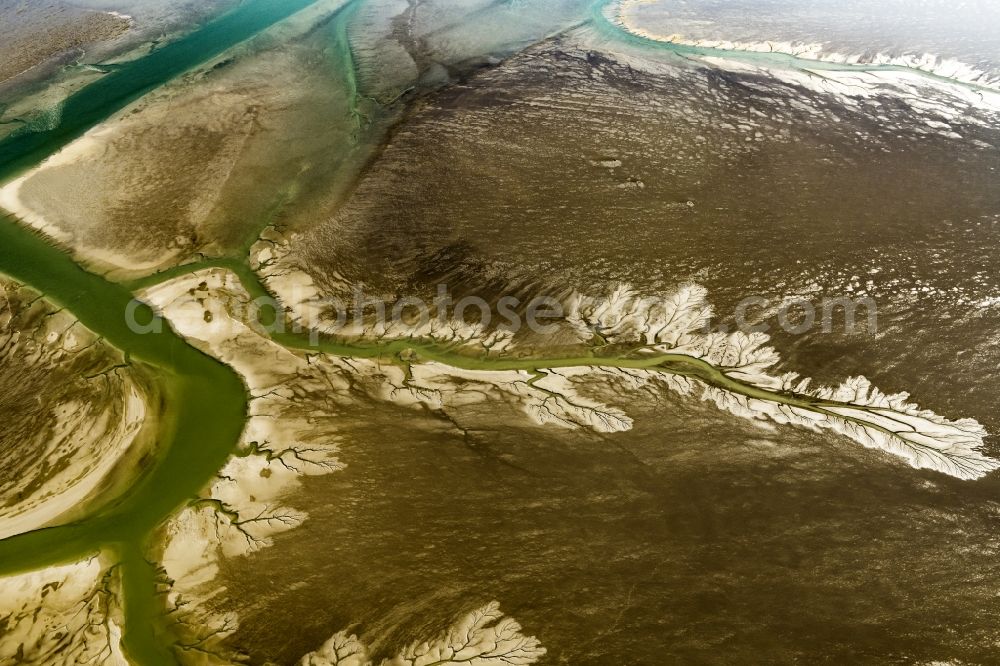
[0,274,159,537]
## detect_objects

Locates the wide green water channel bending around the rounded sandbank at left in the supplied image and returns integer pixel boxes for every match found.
[0,217,248,664]
